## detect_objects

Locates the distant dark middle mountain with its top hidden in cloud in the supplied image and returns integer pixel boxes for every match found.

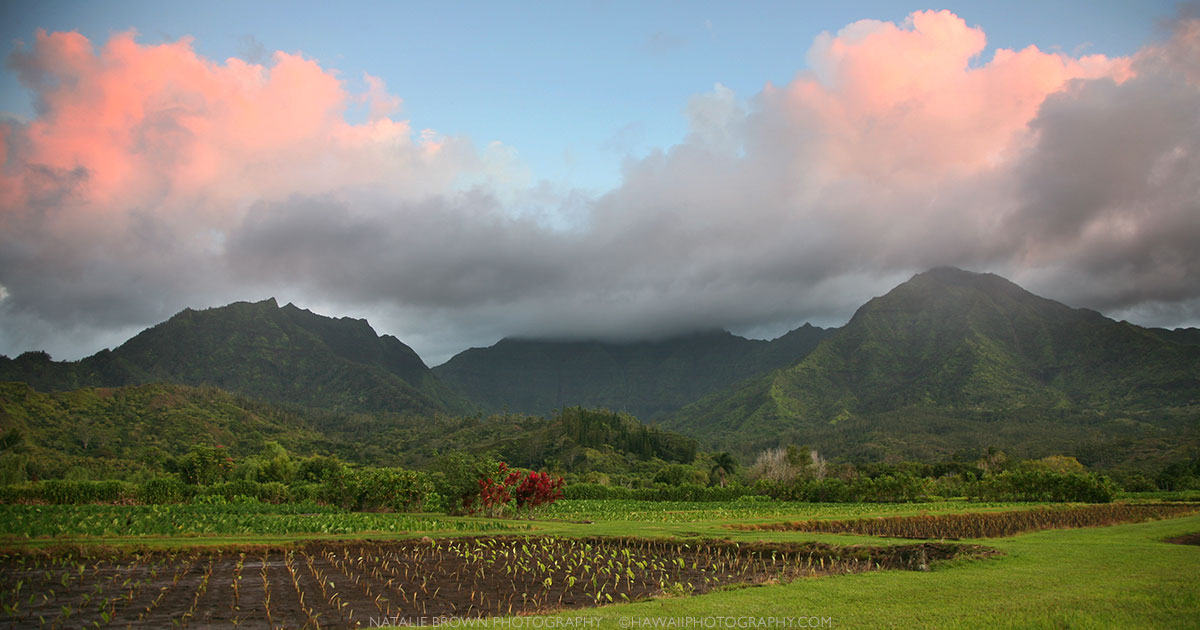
[433,325,829,419]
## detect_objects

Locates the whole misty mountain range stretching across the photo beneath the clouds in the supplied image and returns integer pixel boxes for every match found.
[0,269,1200,466]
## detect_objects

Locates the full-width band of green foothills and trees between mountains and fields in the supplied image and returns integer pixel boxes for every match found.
[7,374,1200,510]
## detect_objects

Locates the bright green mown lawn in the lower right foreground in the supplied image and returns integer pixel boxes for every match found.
[528,508,1200,629]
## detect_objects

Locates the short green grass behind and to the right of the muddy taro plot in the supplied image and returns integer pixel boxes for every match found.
[0,502,1200,629]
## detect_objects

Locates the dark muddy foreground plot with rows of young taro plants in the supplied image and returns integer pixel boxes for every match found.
[0,536,994,630]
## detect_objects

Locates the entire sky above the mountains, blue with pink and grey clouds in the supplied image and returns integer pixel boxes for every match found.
[0,0,1200,365]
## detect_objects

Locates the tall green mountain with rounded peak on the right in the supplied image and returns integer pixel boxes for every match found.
[665,269,1200,457]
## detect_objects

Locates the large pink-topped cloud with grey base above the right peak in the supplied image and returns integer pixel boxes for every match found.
[593,12,1200,333]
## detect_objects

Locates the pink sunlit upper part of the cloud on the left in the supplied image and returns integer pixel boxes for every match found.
[0,31,476,227]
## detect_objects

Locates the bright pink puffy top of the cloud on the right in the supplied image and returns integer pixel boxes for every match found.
[766,11,1132,186]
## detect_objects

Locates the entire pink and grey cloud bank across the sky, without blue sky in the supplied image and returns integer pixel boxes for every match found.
[0,11,1200,362]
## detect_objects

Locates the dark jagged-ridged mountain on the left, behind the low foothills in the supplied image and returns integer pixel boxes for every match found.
[0,299,474,414]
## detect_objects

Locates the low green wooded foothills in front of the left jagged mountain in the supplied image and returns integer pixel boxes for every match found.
[0,383,696,478]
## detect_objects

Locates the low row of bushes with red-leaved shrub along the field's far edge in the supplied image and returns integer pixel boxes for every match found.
[0,446,1142,508]
